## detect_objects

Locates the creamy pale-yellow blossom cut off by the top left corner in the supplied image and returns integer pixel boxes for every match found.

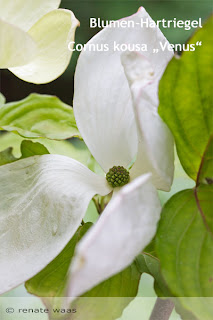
[0,0,79,84]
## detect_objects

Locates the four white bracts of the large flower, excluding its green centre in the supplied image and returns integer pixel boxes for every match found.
[0,8,174,296]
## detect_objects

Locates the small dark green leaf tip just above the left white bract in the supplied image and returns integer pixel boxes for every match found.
[21,140,49,158]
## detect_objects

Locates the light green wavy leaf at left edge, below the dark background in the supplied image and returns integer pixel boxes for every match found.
[0,94,80,140]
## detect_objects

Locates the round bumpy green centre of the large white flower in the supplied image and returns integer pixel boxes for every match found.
[106,166,129,188]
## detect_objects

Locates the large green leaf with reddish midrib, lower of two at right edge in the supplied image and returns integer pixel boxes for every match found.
[156,185,213,320]
